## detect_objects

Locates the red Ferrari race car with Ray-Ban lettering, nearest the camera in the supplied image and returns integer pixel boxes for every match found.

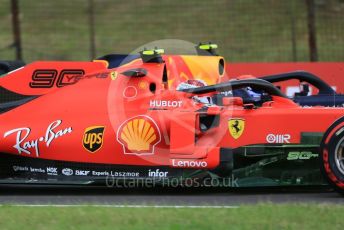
[0,46,344,194]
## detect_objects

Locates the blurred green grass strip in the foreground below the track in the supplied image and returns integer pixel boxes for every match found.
[0,204,344,230]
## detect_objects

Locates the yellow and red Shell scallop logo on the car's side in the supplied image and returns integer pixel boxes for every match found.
[117,115,161,155]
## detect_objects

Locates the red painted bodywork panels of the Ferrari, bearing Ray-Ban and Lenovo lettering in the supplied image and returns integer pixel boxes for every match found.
[0,55,344,168]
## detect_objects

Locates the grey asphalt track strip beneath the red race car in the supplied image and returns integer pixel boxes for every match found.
[0,185,344,206]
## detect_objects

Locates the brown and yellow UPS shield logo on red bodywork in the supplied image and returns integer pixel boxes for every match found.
[82,126,105,153]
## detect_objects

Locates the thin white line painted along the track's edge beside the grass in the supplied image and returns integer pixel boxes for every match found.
[0,204,238,209]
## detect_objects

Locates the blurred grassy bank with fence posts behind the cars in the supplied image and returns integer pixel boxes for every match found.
[0,0,344,62]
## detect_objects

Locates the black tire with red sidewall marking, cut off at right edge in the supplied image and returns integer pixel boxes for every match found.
[320,117,344,195]
